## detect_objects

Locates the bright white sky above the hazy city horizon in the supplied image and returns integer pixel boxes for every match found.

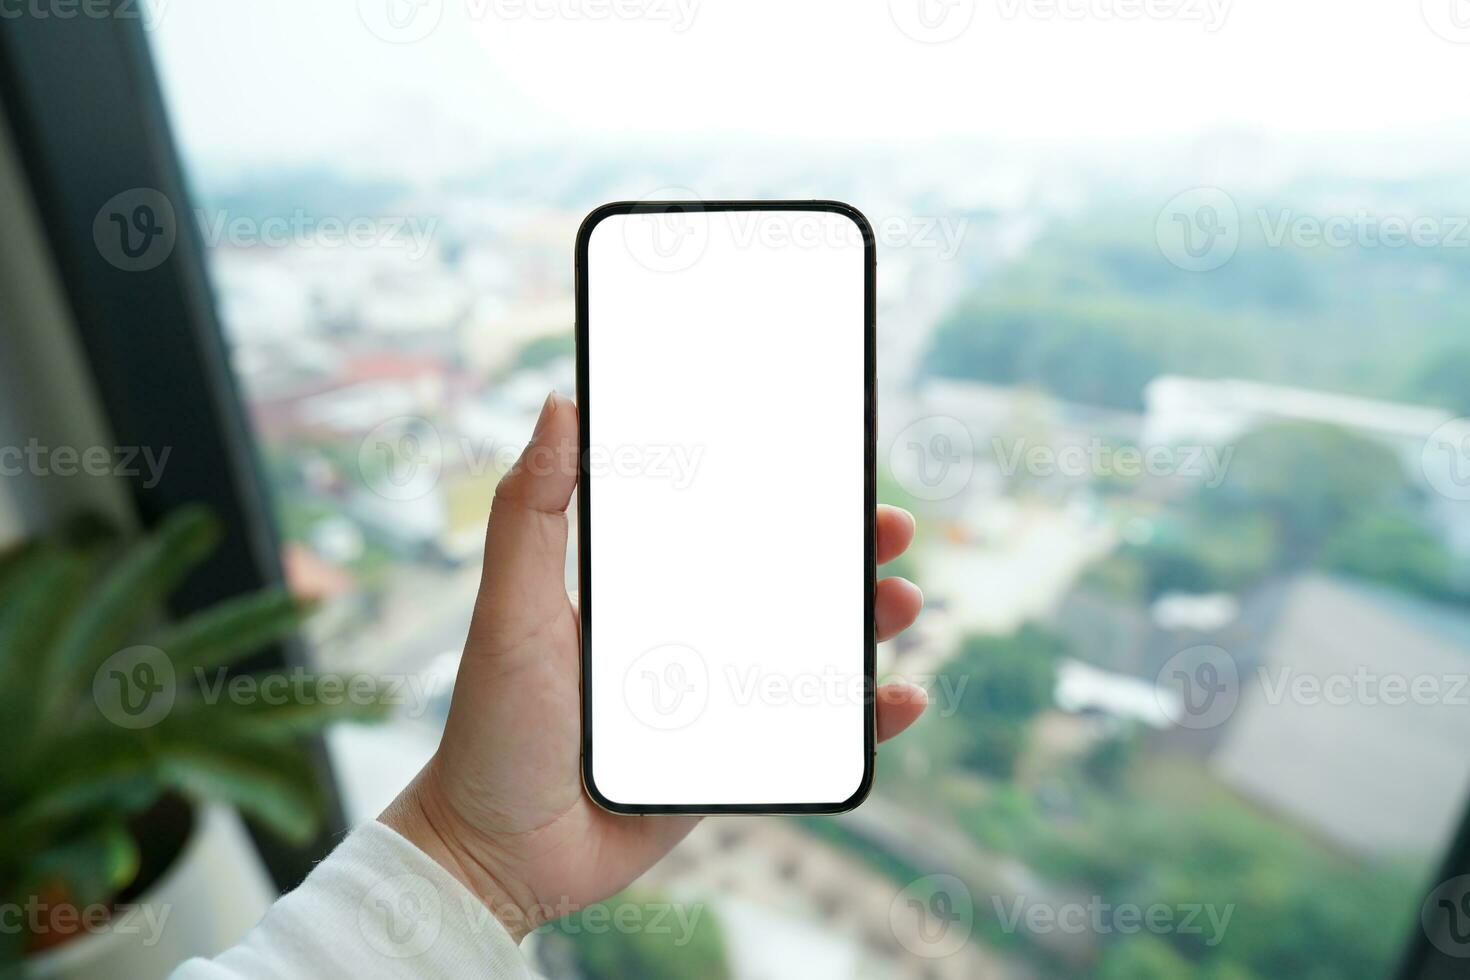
[150,0,1470,174]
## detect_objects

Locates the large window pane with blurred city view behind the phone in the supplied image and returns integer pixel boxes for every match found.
[151,0,1470,977]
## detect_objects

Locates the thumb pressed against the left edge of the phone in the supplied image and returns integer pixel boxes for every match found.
[476,392,578,642]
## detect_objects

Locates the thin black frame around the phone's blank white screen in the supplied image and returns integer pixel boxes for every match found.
[573,201,878,814]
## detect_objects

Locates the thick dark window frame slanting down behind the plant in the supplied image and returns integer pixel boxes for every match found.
[0,0,347,889]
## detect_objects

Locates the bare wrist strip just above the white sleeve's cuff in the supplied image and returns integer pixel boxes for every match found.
[378,760,545,943]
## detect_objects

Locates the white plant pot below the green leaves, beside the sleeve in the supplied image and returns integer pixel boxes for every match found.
[25,804,276,980]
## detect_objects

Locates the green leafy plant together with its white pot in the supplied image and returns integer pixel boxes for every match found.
[0,507,385,977]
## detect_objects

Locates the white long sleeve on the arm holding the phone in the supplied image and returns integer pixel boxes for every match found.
[172,821,535,980]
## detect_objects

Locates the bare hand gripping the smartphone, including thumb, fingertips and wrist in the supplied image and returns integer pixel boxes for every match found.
[379,394,928,942]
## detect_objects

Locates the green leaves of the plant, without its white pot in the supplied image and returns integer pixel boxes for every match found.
[0,507,385,964]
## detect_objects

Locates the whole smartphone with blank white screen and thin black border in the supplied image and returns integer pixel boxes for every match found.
[575,201,876,814]
